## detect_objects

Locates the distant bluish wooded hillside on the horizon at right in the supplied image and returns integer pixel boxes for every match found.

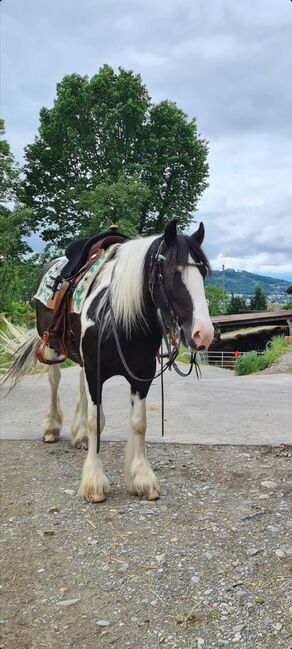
[206,268,291,302]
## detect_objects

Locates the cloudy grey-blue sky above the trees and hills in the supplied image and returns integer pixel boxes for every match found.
[1,0,292,280]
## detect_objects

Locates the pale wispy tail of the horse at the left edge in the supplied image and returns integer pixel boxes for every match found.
[0,316,40,387]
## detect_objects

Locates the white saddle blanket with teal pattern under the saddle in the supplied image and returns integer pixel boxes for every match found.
[34,243,120,313]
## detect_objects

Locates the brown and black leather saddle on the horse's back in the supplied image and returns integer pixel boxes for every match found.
[36,226,129,365]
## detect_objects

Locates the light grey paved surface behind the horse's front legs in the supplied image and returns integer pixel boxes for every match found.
[0,366,292,445]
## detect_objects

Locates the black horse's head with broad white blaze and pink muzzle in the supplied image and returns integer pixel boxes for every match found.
[153,220,214,349]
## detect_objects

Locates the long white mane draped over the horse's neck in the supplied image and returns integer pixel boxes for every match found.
[85,235,159,335]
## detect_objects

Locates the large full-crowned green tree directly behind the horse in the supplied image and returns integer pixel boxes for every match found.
[22,65,208,245]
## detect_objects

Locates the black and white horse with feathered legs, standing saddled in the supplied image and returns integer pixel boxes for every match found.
[6,221,214,502]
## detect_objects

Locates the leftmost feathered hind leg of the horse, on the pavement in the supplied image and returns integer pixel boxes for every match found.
[43,365,63,443]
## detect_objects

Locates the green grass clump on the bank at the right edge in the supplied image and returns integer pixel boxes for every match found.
[235,336,288,376]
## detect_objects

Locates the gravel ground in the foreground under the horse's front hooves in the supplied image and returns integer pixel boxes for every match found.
[0,441,292,649]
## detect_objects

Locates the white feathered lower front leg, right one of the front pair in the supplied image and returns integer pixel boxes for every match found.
[125,386,160,500]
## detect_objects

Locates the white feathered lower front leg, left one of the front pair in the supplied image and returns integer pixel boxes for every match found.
[78,400,110,502]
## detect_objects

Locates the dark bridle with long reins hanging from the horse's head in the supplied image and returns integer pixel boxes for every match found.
[96,239,205,453]
